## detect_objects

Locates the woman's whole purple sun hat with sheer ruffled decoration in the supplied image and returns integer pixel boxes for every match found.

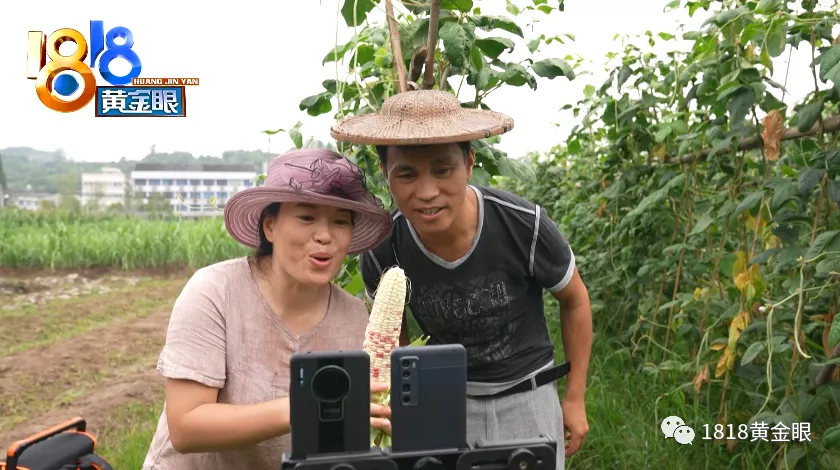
[225,148,392,254]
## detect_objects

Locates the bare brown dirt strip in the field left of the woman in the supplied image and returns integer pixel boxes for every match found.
[0,306,175,446]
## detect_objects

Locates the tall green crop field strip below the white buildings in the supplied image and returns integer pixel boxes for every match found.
[0,210,249,269]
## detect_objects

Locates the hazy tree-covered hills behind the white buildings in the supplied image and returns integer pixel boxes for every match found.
[0,147,268,194]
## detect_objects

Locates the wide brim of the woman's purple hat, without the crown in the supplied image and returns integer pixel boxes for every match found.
[225,187,392,254]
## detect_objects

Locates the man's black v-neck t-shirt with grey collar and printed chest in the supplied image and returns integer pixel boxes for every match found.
[359,186,575,383]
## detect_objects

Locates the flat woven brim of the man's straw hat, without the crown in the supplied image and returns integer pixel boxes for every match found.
[330,108,513,145]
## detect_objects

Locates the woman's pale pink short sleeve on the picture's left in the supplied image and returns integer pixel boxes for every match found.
[157,268,227,388]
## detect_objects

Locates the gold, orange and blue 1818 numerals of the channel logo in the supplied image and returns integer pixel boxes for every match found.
[26,21,142,113]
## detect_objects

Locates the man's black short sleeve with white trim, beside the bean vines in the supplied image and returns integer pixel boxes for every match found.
[531,206,575,293]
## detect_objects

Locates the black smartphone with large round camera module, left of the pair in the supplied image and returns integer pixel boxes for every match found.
[289,350,370,459]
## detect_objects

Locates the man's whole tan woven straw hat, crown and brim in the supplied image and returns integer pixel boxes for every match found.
[330,90,513,145]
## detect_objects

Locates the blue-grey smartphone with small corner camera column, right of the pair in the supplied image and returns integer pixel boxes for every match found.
[391,344,467,452]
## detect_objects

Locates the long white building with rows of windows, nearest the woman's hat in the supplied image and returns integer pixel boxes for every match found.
[131,163,257,216]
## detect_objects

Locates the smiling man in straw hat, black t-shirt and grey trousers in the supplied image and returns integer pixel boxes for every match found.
[331,90,592,468]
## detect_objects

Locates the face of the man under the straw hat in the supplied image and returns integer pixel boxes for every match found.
[382,144,475,233]
